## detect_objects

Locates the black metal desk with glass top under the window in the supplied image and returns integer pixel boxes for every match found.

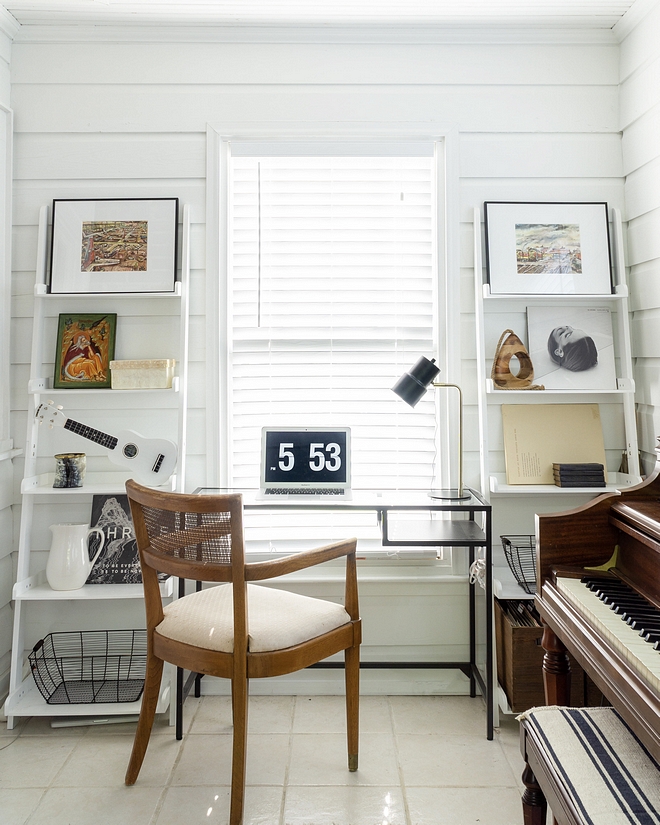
[175,487,495,740]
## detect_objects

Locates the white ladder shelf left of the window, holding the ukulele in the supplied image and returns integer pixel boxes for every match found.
[4,206,190,728]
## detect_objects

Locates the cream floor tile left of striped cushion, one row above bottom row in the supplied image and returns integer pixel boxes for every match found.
[397,734,517,788]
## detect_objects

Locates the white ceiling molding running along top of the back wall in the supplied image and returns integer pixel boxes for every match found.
[10,21,618,45]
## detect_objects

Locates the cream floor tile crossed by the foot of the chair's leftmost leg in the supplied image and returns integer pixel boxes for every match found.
[53,731,181,788]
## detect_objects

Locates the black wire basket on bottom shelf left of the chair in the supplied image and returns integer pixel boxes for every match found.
[28,630,147,705]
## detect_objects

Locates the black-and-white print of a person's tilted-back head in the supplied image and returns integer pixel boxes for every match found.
[527,304,617,390]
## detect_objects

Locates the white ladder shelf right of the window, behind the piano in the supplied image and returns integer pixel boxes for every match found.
[473,208,641,712]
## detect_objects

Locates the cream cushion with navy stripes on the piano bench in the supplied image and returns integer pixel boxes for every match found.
[518,706,660,825]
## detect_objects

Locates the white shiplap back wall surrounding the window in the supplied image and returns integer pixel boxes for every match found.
[3,27,623,696]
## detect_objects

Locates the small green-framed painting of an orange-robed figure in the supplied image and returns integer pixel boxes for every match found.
[53,313,117,389]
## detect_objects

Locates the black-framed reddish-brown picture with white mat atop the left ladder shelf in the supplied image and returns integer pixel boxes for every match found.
[49,198,179,294]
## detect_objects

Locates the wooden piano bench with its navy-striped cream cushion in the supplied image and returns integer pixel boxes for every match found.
[518,706,660,825]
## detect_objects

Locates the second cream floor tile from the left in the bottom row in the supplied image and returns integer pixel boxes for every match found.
[29,785,163,825]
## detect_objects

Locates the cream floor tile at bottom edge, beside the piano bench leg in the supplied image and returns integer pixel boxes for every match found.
[406,788,522,825]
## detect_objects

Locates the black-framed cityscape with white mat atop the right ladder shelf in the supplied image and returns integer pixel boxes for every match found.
[484,202,612,295]
